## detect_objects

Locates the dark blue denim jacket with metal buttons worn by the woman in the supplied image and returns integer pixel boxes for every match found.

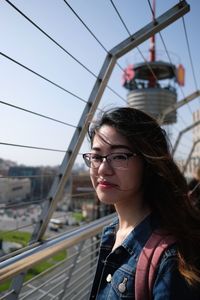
[90,215,200,300]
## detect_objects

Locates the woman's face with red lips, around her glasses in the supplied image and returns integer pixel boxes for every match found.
[90,125,143,204]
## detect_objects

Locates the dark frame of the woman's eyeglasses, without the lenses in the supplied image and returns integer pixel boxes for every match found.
[83,152,137,169]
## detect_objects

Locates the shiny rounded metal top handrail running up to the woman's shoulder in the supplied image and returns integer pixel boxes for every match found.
[0,214,116,284]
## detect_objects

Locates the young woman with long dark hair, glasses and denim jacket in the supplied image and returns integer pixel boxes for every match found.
[83,107,200,300]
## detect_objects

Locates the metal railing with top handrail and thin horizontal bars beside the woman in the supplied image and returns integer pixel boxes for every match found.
[0,214,115,300]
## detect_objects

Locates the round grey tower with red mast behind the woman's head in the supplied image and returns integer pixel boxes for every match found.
[122,0,184,125]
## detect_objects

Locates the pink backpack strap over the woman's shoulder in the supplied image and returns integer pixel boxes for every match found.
[135,232,175,300]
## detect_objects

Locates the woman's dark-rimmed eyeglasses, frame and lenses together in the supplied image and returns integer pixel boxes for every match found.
[83,153,137,169]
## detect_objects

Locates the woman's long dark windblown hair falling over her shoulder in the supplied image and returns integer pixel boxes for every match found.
[88,107,200,285]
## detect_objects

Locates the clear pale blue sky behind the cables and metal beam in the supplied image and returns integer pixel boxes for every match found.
[0,0,200,166]
